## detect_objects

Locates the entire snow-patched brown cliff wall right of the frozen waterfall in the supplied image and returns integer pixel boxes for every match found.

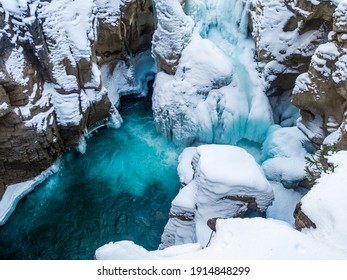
[251,0,347,149]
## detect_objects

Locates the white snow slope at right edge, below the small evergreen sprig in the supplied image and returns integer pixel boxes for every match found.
[301,151,347,253]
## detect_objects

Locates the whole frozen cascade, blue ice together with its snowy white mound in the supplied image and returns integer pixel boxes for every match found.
[153,0,273,145]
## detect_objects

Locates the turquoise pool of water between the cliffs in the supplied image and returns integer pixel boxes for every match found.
[0,97,184,259]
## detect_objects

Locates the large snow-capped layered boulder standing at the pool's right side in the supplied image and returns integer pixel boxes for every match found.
[159,145,273,249]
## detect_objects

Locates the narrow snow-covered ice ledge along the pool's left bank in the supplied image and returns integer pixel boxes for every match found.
[0,160,60,226]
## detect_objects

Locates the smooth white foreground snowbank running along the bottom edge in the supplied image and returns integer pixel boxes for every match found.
[95,218,347,260]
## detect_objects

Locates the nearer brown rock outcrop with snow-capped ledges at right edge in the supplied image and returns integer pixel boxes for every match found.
[293,1,347,149]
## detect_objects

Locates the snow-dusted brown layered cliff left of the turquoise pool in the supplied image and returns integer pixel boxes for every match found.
[0,0,154,197]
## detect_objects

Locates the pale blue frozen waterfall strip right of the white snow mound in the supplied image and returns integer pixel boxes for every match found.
[185,0,273,147]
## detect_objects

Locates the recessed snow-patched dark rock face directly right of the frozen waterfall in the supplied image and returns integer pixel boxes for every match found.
[250,0,336,126]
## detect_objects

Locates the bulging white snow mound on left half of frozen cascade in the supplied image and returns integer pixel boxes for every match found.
[153,33,232,145]
